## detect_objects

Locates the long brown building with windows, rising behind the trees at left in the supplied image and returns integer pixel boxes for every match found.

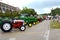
[0,2,20,13]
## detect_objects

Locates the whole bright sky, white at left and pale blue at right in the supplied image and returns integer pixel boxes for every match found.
[0,0,60,14]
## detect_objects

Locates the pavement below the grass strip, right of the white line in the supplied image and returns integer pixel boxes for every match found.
[49,29,60,40]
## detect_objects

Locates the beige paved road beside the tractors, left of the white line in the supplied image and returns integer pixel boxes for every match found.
[0,20,50,40]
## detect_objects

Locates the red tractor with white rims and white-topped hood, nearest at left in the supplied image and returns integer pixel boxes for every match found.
[0,19,26,32]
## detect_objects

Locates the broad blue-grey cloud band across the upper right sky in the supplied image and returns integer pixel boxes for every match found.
[28,0,60,9]
